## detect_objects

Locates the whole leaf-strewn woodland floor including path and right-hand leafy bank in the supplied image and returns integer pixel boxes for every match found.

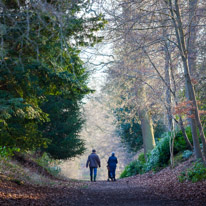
[0,158,206,206]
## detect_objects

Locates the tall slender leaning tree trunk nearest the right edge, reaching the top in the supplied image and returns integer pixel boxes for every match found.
[169,0,206,160]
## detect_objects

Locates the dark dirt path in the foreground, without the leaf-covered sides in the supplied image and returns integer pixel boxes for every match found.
[65,180,185,206]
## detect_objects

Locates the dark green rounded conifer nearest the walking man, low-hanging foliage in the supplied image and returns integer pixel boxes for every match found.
[40,95,85,159]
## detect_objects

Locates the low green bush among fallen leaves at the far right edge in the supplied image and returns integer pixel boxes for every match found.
[178,162,206,182]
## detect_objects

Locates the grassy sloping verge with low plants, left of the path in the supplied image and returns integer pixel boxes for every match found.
[0,151,62,186]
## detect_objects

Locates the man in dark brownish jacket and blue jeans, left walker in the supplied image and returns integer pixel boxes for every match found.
[86,149,101,182]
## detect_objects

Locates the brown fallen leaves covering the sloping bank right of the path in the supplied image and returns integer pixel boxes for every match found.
[120,157,206,205]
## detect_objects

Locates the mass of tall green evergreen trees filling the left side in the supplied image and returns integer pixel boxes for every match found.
[0,0,105,159]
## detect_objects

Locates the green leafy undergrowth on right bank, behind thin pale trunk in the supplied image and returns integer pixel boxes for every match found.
[120,128,193,178]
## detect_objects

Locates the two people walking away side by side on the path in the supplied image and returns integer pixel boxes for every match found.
[86,149,118,182]
